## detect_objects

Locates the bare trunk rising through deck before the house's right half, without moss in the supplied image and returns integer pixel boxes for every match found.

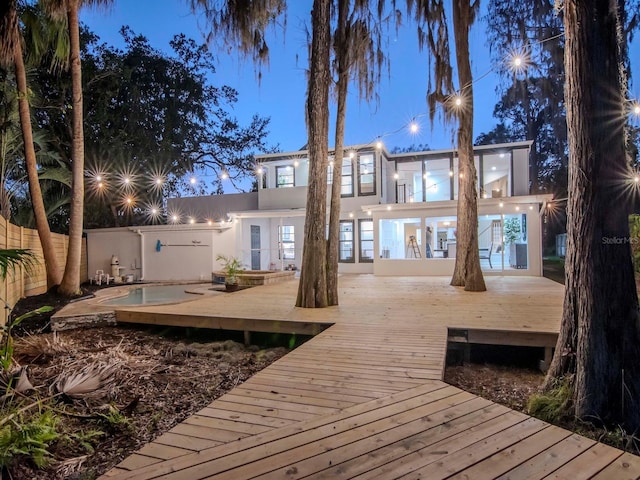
[451,0,487,292]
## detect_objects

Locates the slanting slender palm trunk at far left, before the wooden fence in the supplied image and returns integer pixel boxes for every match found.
[0,0,60,287]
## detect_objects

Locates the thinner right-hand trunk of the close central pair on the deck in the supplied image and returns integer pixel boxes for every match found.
[327,0,350,305]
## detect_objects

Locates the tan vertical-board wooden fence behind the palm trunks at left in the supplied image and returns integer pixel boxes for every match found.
[0,217,88,325]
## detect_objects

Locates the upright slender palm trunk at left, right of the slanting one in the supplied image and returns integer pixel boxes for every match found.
[58,0,84,296]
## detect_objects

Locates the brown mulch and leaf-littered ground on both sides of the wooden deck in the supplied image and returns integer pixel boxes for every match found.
[0,262,639,480]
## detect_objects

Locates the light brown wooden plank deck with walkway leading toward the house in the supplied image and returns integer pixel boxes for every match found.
[104,276,640,480]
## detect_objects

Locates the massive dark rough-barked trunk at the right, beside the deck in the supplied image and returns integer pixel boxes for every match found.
[545,0,640,432]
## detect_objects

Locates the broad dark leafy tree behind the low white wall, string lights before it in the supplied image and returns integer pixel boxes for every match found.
[77,27,271,227]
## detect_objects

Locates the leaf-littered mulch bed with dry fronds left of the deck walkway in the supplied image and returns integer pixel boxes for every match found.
[0,286,288,480]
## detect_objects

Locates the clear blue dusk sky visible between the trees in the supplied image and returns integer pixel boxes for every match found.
[81,0,640,156]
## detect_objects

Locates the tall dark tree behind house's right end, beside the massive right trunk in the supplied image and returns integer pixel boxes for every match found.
[486,0,567,197]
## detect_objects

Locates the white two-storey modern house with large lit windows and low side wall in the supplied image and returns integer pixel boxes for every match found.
[88,142,551,280]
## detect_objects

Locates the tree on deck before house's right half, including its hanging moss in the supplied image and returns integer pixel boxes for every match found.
[407,0,486,292]
